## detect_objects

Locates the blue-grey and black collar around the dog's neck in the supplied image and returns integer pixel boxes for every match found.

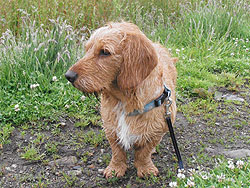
[128,85,171,116]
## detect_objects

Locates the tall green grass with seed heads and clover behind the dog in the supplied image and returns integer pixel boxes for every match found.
[0,0,250,124]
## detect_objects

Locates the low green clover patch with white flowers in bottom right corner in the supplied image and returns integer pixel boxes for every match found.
[169,158,250,187]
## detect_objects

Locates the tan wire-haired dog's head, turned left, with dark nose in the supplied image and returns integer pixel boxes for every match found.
[65,22,158,93]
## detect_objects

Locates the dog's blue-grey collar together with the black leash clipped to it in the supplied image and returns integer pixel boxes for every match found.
[128,85,184,169]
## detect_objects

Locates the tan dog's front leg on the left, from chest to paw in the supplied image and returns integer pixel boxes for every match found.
[104,132,127,178]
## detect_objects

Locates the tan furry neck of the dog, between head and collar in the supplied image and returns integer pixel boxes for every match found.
[103,64,164,113]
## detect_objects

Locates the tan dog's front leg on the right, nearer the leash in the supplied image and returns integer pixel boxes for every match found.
[134,136,161,177]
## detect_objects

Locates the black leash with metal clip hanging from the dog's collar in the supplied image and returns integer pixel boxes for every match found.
[165,88,184,169]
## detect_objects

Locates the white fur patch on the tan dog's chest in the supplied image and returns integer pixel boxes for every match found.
[114,103,141,150]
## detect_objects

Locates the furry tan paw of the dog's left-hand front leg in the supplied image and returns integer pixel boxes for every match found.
[103,164,127,179]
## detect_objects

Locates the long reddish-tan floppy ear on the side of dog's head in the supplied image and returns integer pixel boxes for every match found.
[117,33,158,90]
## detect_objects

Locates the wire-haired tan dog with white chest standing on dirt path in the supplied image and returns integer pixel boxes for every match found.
[65,22,178,178]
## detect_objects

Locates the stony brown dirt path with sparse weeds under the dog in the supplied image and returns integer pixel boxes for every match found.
[0,81,250,188]
